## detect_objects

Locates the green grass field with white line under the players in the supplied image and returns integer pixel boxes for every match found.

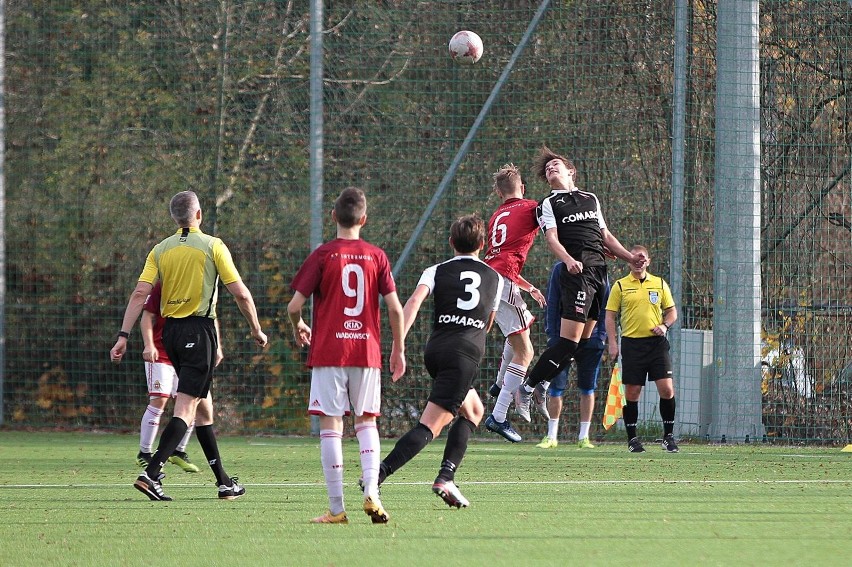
[0,431,852,567]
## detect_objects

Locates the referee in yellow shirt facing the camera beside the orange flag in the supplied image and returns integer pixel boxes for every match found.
[606,246,678,453]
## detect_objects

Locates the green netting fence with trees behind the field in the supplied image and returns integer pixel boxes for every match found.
[3,0,852,442]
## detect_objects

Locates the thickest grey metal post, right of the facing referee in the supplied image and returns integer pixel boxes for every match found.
[709,0,764,441]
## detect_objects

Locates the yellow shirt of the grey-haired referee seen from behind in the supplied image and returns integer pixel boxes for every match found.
[139,228,240,319]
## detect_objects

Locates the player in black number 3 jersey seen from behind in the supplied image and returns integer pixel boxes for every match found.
[379,215,503,508]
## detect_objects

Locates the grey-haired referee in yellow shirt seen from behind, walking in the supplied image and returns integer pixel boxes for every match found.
[110,191,266,500]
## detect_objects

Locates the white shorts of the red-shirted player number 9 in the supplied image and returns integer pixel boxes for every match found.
[308,366,382,417]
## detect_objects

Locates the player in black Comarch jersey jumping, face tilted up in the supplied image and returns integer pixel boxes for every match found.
[515,146,643,414]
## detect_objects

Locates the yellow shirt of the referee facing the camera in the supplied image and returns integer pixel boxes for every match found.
[606,272,674,339]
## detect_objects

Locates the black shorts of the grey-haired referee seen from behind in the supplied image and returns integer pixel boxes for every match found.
[163,317,218,398]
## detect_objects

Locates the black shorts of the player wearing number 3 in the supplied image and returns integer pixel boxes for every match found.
[423,350,479,416]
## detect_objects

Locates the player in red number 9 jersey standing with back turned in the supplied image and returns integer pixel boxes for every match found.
[287,187,405,524]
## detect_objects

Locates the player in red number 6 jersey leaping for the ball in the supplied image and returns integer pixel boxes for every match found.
[484,164,545,443]
